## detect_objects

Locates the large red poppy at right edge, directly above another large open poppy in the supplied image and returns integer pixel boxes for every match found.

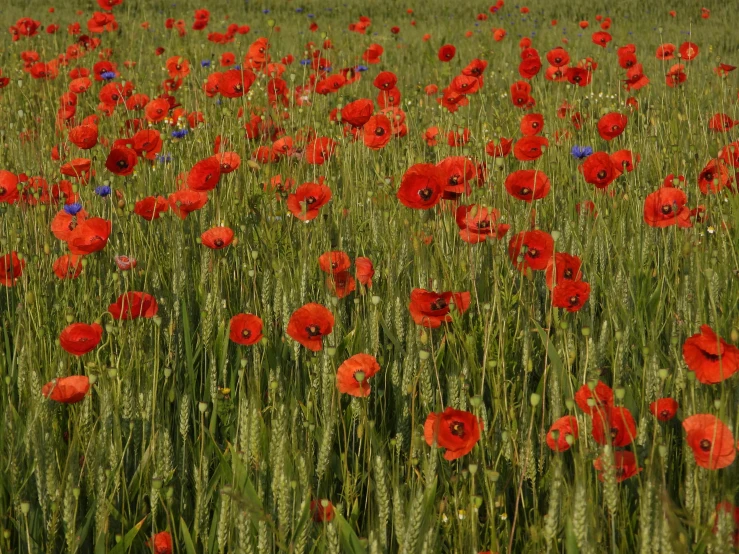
[683,325,739,385]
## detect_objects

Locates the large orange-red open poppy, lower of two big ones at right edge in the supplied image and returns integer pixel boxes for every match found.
[683,414,736,470]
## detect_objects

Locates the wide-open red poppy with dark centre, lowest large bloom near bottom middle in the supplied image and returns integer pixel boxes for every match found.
[423,407,482,460]
